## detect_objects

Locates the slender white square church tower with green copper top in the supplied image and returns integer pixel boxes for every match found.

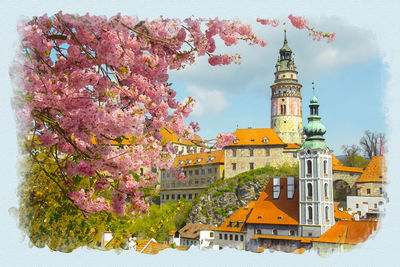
[299,85,335,237]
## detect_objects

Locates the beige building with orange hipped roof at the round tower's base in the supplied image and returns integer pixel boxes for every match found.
[224,128,300,178]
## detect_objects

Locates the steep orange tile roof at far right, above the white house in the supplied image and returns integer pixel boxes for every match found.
[357,156,387,183]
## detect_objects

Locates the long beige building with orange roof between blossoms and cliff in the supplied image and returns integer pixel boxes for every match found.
[160,150,225,204]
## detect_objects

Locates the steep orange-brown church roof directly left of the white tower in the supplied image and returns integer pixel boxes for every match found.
[247,178,299,225]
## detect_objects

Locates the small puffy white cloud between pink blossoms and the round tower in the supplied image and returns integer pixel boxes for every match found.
[186,85,229,117]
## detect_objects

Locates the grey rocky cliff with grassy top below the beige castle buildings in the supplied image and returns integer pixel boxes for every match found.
[187,165,298,225]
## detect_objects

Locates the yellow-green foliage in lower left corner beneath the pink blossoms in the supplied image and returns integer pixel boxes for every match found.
[17,143,132,252]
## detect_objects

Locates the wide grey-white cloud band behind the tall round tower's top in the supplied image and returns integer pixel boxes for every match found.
[170,17,380,96]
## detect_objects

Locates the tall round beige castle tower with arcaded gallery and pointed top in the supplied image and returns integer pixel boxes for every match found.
[271,30,303,144]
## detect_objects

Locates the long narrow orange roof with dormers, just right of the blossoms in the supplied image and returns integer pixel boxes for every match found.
[173,150,225,167]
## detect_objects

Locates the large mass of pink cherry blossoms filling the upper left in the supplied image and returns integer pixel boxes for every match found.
[11,12,268,218]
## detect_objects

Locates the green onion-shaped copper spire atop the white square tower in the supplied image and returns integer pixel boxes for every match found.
[302,82,328,152]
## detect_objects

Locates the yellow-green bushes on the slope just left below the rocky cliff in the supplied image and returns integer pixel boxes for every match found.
[129,202,192,242]
